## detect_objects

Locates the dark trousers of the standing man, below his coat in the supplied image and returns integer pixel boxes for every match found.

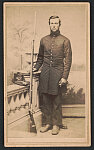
[42,93,62,126]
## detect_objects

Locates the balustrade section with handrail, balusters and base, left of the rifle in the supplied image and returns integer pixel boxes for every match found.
[7,84,30,124]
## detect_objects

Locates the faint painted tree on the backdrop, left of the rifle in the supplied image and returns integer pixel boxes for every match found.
[7,21,33,69]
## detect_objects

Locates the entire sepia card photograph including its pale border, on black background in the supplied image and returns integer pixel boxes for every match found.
[3,2,91,147]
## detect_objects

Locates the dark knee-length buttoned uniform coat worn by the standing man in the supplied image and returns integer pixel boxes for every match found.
[35,31,72,95]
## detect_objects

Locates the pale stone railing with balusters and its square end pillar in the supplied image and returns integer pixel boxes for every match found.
[7,72,40,125]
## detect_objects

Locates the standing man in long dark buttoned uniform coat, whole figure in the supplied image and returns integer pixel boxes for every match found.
[34,16,72,135]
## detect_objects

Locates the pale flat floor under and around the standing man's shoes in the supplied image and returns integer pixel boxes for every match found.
[8,118,85,138]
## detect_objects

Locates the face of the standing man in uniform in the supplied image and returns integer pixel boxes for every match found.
[50,18,60,32]
